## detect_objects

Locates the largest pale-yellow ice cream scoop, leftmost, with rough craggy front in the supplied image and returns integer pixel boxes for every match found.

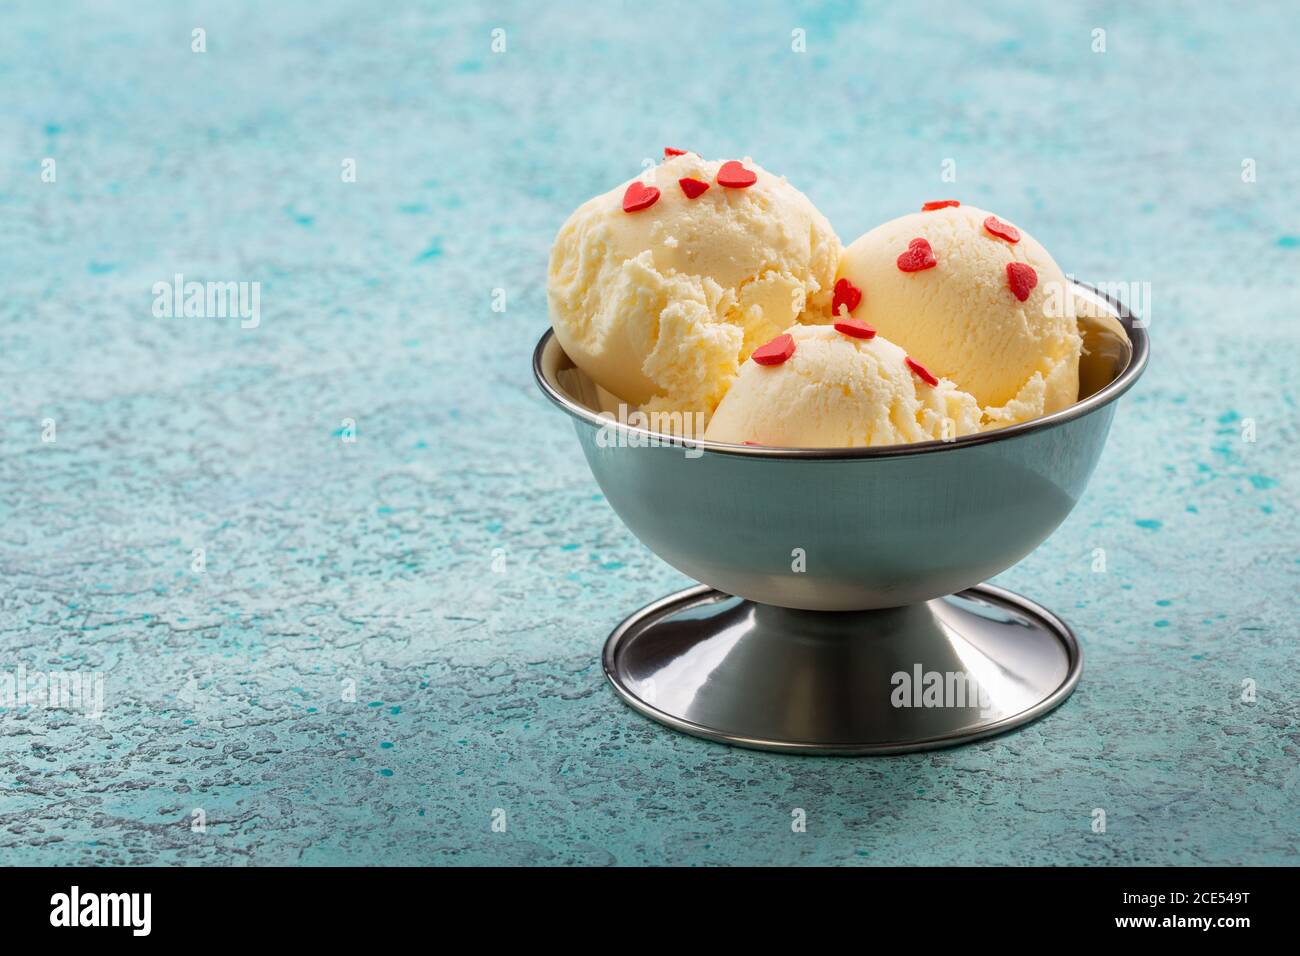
[547,153,841,415]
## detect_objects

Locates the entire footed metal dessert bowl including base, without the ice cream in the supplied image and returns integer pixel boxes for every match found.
[533,285,1148,753]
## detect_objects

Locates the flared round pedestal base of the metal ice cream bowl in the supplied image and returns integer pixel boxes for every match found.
[605,584,1083,754]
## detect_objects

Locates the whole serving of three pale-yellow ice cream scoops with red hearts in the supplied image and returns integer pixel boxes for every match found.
[547,161,1097,447]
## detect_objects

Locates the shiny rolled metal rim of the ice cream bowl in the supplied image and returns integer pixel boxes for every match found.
[533,278,1151,460]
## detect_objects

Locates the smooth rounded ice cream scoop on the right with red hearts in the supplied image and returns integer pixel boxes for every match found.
[839,206,1082,428]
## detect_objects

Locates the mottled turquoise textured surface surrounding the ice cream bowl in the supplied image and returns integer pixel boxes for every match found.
[0,0,1300,864]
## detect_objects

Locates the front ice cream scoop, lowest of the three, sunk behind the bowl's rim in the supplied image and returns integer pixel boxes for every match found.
[705,325,980,447]
